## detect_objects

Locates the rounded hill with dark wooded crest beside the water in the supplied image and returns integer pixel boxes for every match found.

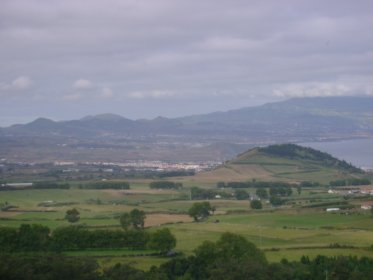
[195,144,364,183]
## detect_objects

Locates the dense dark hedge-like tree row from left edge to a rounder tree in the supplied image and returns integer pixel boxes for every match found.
[0,224,148,253]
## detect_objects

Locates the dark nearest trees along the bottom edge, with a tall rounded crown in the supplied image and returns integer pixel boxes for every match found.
[0,233,373,280]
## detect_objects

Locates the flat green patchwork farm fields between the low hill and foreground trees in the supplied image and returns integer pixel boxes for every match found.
[0,183,373,269]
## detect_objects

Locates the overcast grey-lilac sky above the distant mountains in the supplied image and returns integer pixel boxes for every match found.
[0,0,373,126]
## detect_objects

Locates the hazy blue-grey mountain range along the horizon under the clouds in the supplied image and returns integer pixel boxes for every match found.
[0,97,373,142]
